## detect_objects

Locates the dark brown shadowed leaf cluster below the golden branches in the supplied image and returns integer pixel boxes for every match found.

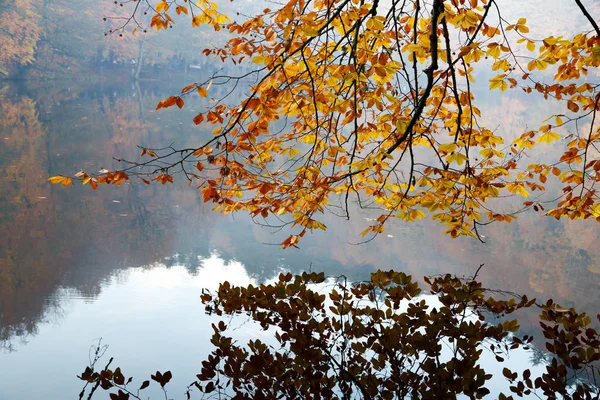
[82,271,600,399]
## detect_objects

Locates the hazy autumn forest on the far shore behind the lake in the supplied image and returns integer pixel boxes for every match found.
[0,0,251,82]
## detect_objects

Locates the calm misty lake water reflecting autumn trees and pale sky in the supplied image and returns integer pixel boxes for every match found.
[0,69,600,400]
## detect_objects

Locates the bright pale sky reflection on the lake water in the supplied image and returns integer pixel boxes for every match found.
[0,254,568,399]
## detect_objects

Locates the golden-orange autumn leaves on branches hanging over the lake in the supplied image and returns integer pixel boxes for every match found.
[55,0,600,247]
